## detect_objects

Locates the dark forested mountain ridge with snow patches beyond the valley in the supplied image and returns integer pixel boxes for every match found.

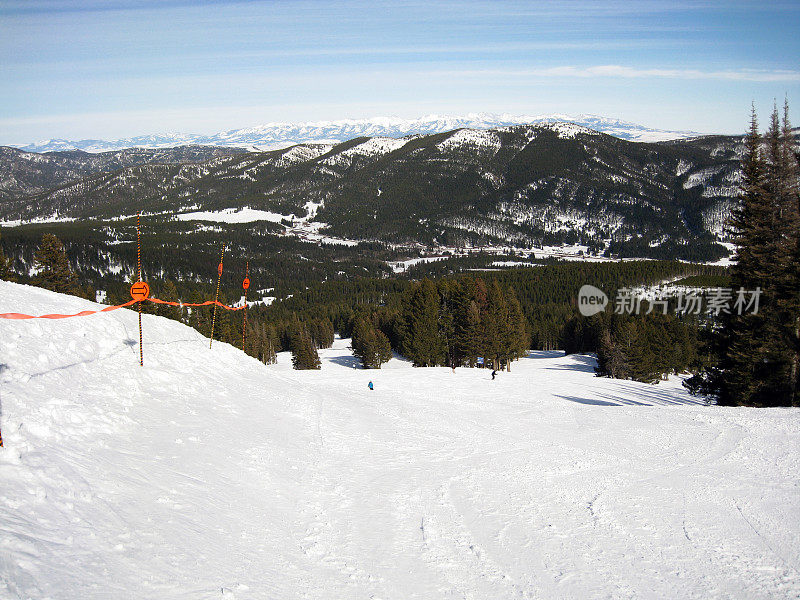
[0,123,792,259]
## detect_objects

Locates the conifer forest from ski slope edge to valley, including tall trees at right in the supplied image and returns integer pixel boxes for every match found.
[0,103,800,406]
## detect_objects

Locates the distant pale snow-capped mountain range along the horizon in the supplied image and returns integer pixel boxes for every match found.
[12,113,700,152]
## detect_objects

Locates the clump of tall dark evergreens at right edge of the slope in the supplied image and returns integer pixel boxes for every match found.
[687,106,800,406]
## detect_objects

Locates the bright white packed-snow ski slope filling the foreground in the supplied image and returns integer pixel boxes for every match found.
[0,282,800,600]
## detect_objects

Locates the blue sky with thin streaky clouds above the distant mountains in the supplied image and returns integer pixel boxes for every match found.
[0,0,800,143]
